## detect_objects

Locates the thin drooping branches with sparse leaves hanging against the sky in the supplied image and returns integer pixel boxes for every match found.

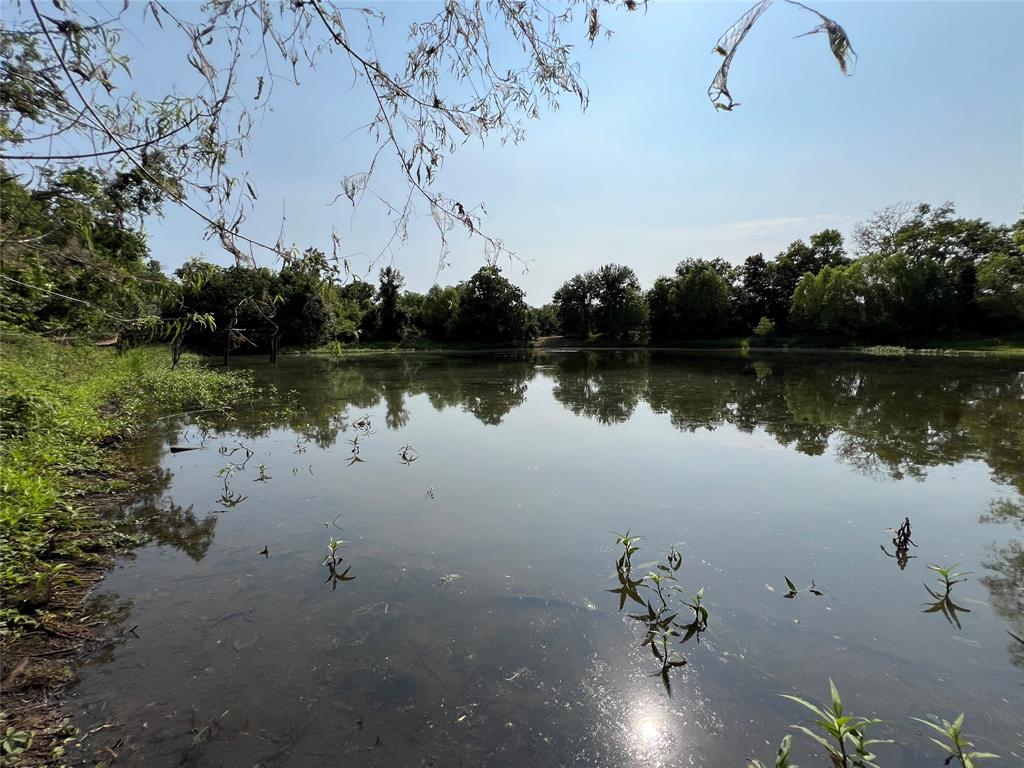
[0,0,852,267]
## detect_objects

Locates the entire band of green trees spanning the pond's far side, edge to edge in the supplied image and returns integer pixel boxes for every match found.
[0,167,1024,346]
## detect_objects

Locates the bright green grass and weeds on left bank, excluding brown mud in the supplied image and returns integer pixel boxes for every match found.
[0,329,255,634]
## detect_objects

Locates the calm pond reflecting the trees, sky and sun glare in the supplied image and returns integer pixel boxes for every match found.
[72,351,1024,768]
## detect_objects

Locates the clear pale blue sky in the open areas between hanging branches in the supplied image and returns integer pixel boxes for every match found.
[88,0,1024,304]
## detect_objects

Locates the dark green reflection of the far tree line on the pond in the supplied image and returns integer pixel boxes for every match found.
[237,351,1024,494]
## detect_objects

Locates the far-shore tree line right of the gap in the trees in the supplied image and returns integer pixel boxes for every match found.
[553,204,1024,343]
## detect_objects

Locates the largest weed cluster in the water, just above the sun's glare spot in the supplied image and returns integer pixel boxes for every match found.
[608,531,708,695]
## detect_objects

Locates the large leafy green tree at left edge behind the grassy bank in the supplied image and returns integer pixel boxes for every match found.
[0,166,174,334]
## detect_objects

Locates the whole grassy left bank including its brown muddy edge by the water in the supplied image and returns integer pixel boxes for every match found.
[0,330,262,765]
